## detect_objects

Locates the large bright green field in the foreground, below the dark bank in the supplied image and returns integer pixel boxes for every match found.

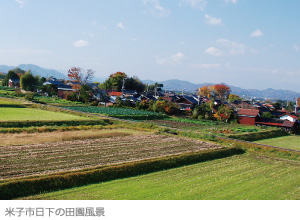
[25,154,300,200]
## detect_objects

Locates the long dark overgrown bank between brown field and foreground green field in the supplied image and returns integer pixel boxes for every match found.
[0,148,245,199]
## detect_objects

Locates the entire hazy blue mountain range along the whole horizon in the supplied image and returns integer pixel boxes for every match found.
[0,64,300,101]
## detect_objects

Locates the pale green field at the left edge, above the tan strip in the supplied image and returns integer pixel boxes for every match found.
[0,107,86,121]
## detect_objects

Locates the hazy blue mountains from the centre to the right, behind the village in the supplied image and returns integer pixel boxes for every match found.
[142,79,300,101]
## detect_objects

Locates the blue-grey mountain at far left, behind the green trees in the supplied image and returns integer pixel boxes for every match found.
[0,64,67,79]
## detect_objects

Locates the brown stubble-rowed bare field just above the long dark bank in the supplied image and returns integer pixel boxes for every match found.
[0,135,222,180]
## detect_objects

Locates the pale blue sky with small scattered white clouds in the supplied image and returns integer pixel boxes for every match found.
[0,0,300,92]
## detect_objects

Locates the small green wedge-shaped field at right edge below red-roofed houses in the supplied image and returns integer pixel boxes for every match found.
[256,135,300,150]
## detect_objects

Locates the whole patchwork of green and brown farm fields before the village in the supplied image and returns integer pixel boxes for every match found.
[0,95,300,199]
